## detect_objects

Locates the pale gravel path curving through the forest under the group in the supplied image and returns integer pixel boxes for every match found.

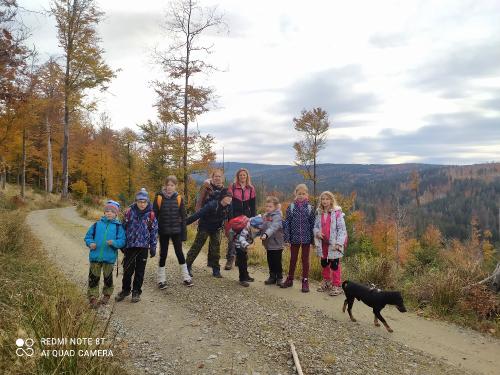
[28,208,500,374]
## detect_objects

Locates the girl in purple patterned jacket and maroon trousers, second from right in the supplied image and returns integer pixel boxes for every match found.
[281,184,315,293]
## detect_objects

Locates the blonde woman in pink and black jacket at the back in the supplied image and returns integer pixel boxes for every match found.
[224,168,256,270]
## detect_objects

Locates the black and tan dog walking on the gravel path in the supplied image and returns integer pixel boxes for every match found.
[342,280,406,332]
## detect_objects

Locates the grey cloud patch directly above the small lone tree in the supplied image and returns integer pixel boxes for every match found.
[281,65,378,116]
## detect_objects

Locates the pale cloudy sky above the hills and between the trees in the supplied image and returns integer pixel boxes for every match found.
[18,0,500,164]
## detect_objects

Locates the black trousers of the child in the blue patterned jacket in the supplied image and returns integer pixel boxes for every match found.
[122,247,148,294]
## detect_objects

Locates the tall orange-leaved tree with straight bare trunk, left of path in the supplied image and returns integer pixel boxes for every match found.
[51,0,114,198]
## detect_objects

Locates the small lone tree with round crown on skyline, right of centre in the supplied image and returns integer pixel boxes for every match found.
[293,107,330,200]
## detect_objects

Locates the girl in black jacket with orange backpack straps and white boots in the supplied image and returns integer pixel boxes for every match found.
[153,176,193,289]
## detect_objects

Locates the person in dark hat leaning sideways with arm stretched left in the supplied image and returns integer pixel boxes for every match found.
[186,189,232,277]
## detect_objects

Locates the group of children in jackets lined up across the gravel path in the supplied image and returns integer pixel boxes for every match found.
[85,172,347,307]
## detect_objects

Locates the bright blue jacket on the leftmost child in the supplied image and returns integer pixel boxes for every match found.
[85,216,125,264]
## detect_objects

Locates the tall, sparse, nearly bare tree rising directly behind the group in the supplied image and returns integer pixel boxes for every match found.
[153,0,223,197]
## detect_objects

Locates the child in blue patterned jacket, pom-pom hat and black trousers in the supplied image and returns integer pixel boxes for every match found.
[115,188,158,302]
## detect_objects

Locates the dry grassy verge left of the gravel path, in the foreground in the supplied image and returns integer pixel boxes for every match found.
[0,187,126,375]
